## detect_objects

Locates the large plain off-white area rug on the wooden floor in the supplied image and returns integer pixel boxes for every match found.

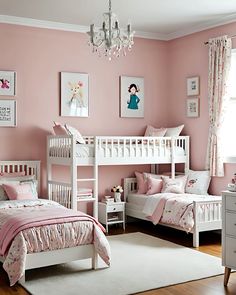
[21,233,224,295]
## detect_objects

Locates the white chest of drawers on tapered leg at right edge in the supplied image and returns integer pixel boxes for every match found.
[222,191,236,286]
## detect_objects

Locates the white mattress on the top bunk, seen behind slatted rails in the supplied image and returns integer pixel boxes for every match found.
[49,144,185,158]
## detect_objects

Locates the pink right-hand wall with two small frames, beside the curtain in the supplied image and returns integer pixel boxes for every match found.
[168,23,236,194]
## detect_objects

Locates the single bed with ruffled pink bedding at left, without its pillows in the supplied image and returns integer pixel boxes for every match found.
[0,161,110,285]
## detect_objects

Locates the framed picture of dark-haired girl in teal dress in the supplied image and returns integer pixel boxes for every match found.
[120,76,144,118]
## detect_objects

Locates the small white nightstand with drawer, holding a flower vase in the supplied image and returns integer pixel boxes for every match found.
[98,202,125,232]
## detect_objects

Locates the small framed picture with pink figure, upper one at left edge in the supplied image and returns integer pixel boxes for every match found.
[0,71,16,96]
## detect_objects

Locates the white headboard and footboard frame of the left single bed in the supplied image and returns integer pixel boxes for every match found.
[0,161,98,283]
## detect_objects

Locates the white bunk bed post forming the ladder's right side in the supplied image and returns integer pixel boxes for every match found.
[93,136,98,218]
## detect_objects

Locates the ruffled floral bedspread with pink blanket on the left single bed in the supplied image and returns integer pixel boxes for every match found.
[0,200,110,285]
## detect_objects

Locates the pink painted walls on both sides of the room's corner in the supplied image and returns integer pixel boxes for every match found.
[0,23,236,194]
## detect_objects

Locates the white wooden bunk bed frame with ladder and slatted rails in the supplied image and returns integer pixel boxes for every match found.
[47,135,189,218]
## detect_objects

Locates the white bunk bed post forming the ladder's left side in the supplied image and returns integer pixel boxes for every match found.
[70,135,78,210]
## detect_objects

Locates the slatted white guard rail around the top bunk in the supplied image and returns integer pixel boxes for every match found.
[47,135,189,169]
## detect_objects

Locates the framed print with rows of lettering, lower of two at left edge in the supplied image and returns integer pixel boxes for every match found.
[0,99,16,127]
